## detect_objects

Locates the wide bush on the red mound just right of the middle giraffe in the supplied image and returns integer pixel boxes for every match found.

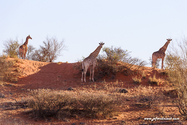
[97,47,146,77]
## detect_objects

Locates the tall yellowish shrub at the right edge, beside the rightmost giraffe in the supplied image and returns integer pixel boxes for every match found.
[166,40,187,117]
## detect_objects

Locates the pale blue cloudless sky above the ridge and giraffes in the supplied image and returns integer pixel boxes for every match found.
[0,0,187,66]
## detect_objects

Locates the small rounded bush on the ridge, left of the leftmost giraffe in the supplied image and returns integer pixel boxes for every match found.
[3,39,19,58]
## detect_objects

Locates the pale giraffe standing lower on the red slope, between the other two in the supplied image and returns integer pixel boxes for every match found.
[81,42,104,82]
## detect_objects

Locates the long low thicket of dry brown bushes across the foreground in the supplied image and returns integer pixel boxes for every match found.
[27,89,120,118]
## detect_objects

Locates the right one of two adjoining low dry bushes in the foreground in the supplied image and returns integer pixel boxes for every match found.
[79,93,120,118]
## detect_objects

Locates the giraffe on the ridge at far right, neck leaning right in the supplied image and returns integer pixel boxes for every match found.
[152,39,172,69]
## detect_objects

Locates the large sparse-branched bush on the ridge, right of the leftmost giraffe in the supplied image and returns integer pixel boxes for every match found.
[32,38,66,62]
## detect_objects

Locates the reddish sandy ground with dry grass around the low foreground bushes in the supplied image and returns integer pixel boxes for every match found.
[0,58,187,125]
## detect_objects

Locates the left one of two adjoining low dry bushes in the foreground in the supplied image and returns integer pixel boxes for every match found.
[27,89,75,118]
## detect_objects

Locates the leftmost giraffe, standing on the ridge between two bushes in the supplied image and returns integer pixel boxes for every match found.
[19,35,32,59]
